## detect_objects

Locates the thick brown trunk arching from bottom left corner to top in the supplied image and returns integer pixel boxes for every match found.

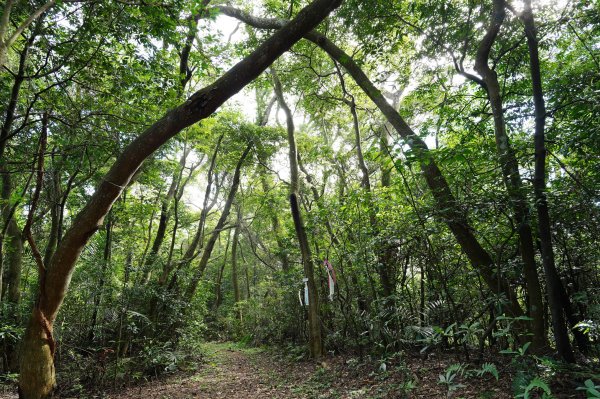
[19,0,341,399]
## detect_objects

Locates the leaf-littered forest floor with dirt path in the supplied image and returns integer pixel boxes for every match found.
[102,343,512,399]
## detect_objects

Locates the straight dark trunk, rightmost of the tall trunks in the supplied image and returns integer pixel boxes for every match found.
[522,0,585,363]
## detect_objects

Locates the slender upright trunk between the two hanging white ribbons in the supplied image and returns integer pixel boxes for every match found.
[271,70,324,358]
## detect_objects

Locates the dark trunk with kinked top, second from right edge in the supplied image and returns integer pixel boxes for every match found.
[475,0,547,352]
